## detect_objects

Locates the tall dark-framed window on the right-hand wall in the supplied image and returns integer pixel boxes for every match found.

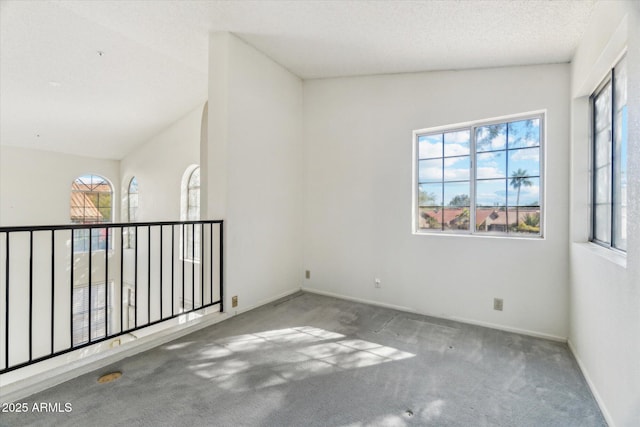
[591,57,628,251]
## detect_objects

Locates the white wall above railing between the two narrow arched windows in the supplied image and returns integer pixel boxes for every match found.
[120,105,204,221]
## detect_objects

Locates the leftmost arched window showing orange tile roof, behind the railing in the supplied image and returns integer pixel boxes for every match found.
[70,174,113,252]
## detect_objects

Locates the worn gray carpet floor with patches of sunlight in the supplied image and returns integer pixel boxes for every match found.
[0,293,606,427]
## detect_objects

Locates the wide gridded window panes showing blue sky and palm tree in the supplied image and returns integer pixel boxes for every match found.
[414,114,544,237]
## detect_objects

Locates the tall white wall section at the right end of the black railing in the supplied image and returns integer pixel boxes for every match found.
[203,33,303,312]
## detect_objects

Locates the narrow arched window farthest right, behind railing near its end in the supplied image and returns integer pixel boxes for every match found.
[180,165,200,261]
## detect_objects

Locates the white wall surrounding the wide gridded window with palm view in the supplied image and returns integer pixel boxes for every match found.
[303,64,570,338]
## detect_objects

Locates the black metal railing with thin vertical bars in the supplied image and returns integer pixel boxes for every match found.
[0,220,224,374]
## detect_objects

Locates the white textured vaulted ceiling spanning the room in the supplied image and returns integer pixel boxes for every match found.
[0,0,595,159]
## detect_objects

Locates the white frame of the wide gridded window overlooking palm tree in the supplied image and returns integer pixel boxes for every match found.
[412,110,547,239]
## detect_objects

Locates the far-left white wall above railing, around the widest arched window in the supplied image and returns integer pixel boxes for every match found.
[0,145,120,226]
